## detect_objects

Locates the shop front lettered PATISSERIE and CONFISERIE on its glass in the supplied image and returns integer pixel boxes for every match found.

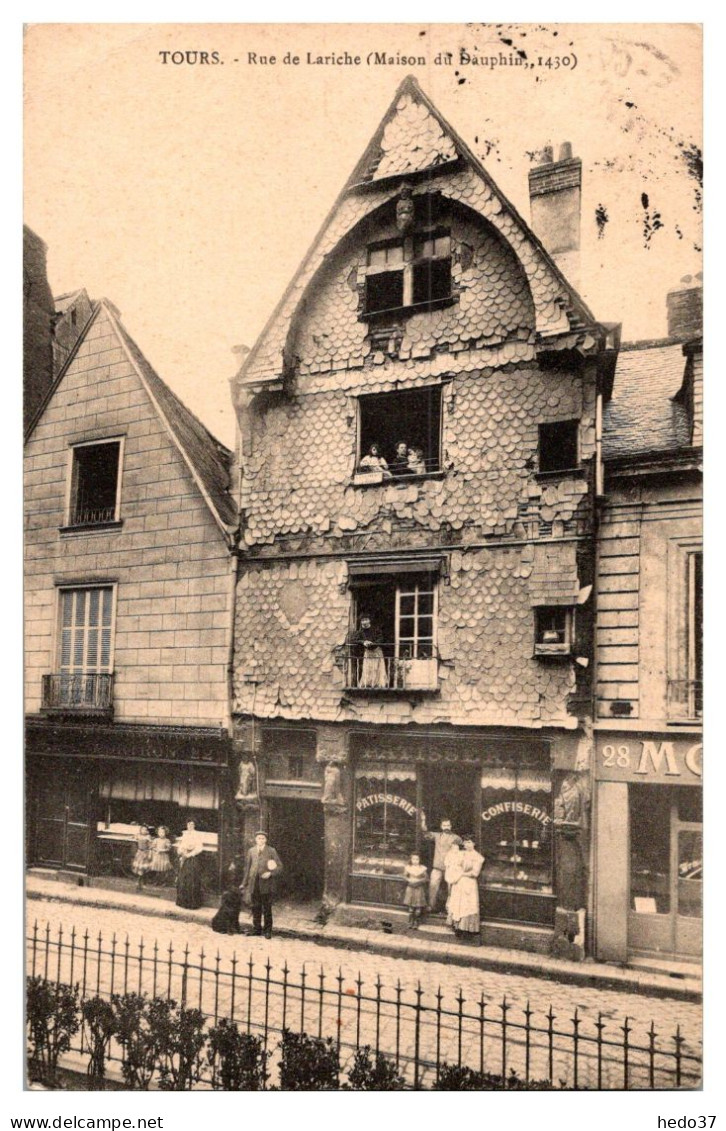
[349,733,555,927]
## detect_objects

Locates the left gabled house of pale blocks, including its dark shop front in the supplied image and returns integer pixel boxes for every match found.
[25,291,236,890]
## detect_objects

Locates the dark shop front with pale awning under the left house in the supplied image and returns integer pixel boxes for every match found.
[27,724,227,891]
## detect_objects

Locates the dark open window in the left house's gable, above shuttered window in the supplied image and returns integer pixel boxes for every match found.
[67,439,123,527]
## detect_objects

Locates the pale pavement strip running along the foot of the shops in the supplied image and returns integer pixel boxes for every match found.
[26,873,702,1002]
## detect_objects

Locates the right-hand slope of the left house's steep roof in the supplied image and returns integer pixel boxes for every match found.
[110,311,237,527]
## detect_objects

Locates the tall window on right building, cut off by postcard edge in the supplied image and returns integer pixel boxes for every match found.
[667,542,703,722]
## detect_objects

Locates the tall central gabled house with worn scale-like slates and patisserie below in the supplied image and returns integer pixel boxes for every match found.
[233,79,616,955]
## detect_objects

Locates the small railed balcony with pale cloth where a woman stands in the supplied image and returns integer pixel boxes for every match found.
[339,644,439,693]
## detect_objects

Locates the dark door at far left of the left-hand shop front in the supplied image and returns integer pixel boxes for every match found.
[34,766,94,872]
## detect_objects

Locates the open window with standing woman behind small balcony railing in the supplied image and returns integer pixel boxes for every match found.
[344,573,439,691]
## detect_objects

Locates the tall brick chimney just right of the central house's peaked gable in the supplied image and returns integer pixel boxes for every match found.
[529,141,582,288]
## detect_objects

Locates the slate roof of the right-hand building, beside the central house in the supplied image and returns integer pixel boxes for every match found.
[603,339,691,459]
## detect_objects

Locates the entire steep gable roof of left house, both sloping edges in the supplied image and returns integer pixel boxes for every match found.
[26,291,237,538]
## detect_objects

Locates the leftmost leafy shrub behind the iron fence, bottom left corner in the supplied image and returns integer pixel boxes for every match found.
[27,977,80,1087]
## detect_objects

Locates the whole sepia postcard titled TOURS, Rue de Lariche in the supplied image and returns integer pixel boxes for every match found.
[24,23,703,1094]
